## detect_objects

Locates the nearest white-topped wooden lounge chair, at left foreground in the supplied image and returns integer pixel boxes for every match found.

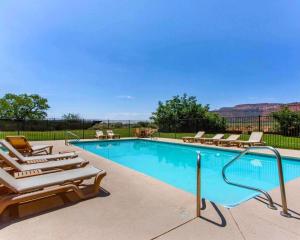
[0,166,106,214]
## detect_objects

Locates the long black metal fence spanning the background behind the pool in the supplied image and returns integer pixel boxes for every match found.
[0,116,300,149]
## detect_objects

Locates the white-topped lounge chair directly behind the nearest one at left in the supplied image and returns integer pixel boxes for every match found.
[0,149,89,177]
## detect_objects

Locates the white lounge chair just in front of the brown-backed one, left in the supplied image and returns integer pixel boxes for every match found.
[0,140,78,163]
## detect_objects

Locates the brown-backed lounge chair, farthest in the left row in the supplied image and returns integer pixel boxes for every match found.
[5,136,53,155]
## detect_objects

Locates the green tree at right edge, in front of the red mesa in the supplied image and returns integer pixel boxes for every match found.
[271,107,300,136]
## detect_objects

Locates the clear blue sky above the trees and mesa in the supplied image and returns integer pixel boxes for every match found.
[0,0,300,119]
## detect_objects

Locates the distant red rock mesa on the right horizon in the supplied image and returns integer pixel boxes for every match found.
[214,102,300,117]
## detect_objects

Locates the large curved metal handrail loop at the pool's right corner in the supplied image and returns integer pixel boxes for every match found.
[222,146,290,217]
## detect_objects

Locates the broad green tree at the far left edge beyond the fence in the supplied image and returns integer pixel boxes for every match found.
[0,93,50,120]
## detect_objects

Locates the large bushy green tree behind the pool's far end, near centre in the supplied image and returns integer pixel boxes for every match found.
[151,94,226,132]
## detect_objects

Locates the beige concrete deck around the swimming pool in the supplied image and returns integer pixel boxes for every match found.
[0,139,300,240]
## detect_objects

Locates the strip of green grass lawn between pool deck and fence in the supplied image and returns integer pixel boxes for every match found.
[0,128,300,149]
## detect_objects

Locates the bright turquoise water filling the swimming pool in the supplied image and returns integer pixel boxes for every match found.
[74,140,300,207]
